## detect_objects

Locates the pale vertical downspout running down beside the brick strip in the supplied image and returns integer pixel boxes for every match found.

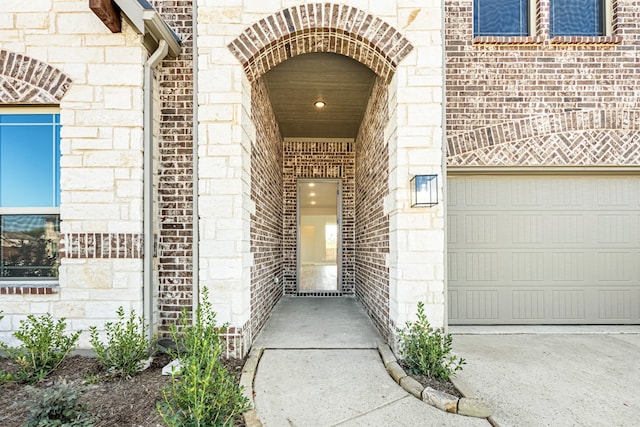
[142,40,169,339]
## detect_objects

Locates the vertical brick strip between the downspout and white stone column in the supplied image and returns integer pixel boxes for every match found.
[151,0,197,334]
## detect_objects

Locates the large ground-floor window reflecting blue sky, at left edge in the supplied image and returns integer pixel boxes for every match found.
[0,110,60,280]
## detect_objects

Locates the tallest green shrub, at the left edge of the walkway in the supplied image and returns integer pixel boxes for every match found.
[158,289,250,427]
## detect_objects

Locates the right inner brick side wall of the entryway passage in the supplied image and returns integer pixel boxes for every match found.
[355,79,389,338]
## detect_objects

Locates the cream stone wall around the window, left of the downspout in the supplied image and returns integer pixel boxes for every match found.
[0,0,147,347]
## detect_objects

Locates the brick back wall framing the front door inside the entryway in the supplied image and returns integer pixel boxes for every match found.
[283,139,355,295]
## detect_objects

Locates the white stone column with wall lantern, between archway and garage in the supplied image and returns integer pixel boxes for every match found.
[385,0,445,338]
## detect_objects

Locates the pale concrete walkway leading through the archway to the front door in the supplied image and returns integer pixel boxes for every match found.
[254,297,489,427]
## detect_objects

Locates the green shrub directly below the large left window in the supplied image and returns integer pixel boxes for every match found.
[0,313,80,383]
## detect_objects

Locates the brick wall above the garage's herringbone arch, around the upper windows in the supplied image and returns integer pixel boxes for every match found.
[445,0,640,143]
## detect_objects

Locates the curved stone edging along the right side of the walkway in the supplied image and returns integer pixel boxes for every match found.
[378,343,497,427]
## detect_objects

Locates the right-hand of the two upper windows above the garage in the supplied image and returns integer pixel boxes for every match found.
[550,0,608,37]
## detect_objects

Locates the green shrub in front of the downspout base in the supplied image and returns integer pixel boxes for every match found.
[89,307,150,377]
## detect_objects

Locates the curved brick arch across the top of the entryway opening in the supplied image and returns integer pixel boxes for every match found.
[228,3,413,82]
